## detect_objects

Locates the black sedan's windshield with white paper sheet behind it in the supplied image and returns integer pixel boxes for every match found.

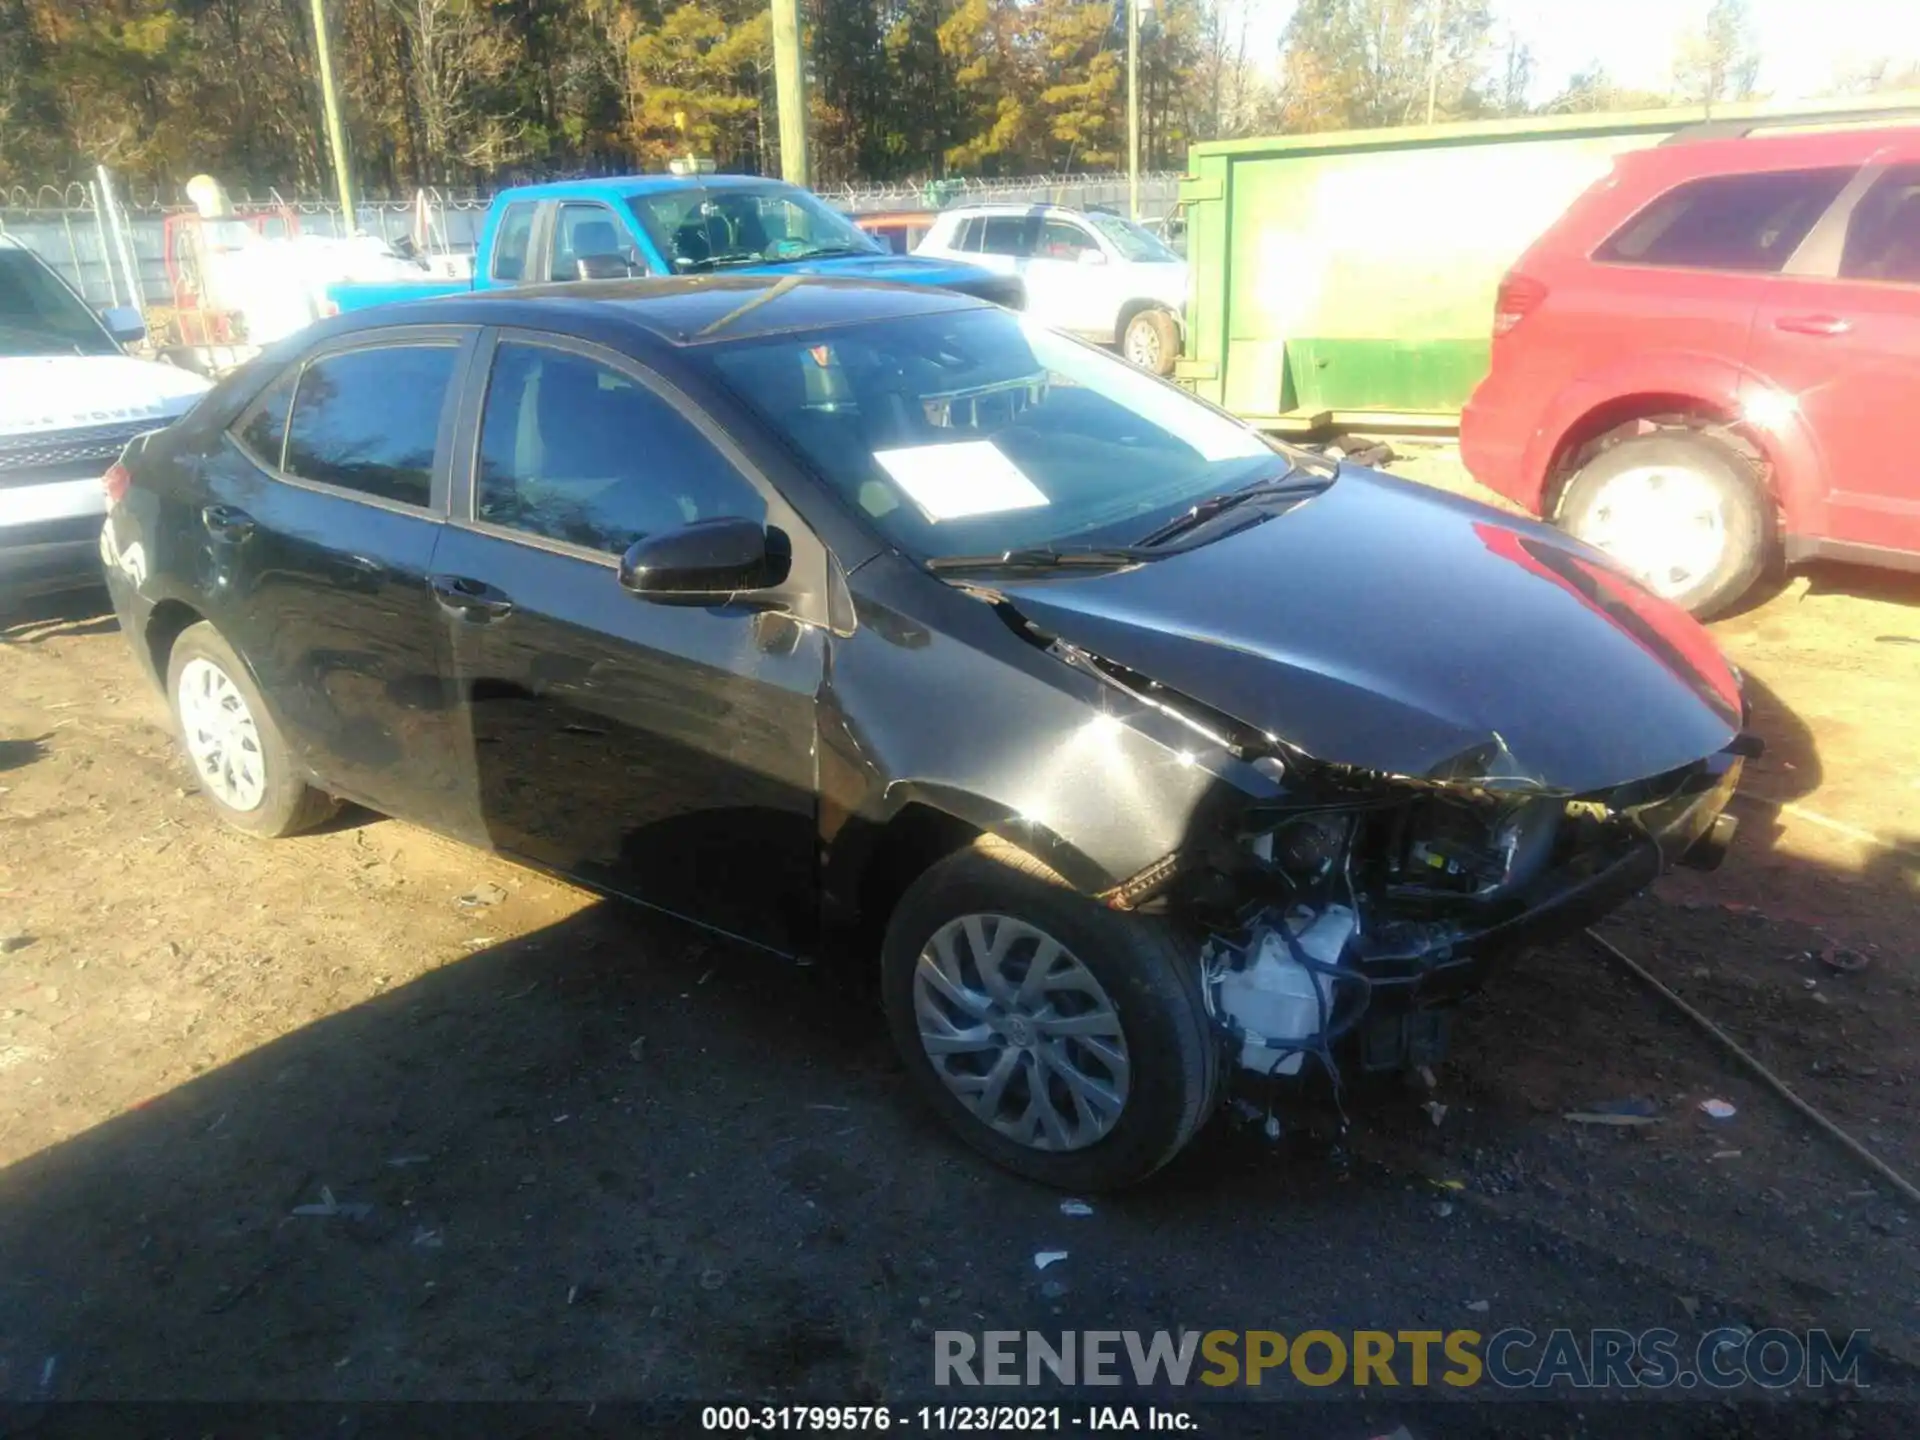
[697,309,1294,561]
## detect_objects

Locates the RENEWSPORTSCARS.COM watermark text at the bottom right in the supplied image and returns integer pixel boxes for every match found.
[933,1327,1868,1394]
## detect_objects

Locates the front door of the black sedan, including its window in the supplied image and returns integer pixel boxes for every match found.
[432,332,826,950]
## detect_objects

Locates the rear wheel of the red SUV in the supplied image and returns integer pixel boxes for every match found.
[1557,430,1774,618]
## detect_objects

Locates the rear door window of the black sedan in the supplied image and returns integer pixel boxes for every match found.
[284,344,459,509]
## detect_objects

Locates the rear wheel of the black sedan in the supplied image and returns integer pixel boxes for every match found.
[167,620,340,839]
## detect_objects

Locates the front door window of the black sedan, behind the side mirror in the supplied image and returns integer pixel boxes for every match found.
[474,342,766,555]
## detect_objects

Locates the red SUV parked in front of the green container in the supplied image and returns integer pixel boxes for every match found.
[1459,127,1920,614]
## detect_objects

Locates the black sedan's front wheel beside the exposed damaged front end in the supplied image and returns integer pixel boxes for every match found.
[881,837,1219,1190]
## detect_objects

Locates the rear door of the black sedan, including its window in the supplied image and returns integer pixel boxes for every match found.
[211,326,476,837]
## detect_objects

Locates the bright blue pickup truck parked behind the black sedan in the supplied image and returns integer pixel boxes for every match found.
[326,175,1025,313]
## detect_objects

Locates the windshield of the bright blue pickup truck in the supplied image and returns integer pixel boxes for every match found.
[626,180,885,273]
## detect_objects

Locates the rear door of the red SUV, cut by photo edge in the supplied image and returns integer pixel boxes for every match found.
[1751,144,1920,551]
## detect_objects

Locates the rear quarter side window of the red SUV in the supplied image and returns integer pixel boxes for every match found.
[1597,165,1857,275]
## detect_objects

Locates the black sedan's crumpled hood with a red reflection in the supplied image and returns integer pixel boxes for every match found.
[998,467,1741,793]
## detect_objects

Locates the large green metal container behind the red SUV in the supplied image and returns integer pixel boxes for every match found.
[1177,94,1914,430]
